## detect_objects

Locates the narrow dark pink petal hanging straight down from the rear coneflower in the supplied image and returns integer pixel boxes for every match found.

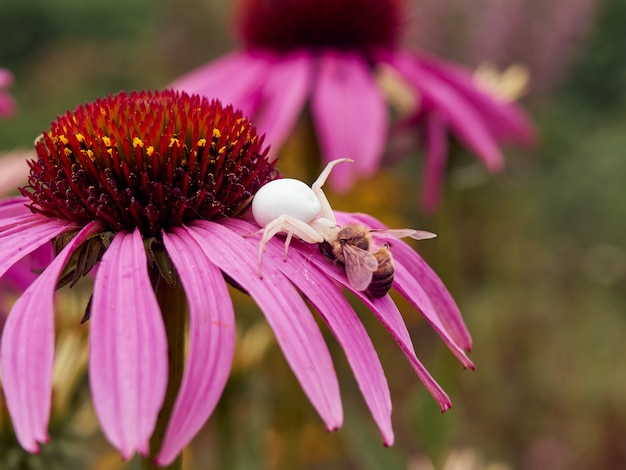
[422,111,448,212]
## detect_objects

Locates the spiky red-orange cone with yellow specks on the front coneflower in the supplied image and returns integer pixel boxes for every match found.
[22,91,274,236]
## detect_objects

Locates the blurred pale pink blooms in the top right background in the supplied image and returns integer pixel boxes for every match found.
[407,0,605,98]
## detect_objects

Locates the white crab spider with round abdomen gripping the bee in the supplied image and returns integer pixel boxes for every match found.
[252,158,354,277]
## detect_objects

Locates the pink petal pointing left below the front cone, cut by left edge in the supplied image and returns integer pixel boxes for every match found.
[0,214,71,276]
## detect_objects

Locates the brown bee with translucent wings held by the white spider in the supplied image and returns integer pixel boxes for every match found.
[318,224,435,299]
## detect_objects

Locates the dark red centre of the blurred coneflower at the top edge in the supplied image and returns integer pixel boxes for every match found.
[238,0,405,53]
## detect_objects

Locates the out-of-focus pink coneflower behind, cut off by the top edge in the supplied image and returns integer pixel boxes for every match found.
[172,0,532,209]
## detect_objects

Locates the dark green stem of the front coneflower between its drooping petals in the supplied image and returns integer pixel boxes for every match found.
[141,279,187,470]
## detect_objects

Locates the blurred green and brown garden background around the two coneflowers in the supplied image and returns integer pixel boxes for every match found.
[0,0,626,470]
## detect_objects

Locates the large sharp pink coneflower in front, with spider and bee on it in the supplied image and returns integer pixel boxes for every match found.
[0,91,473,465]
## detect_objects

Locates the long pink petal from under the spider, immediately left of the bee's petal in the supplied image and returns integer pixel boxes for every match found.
[225,219,393,445]
